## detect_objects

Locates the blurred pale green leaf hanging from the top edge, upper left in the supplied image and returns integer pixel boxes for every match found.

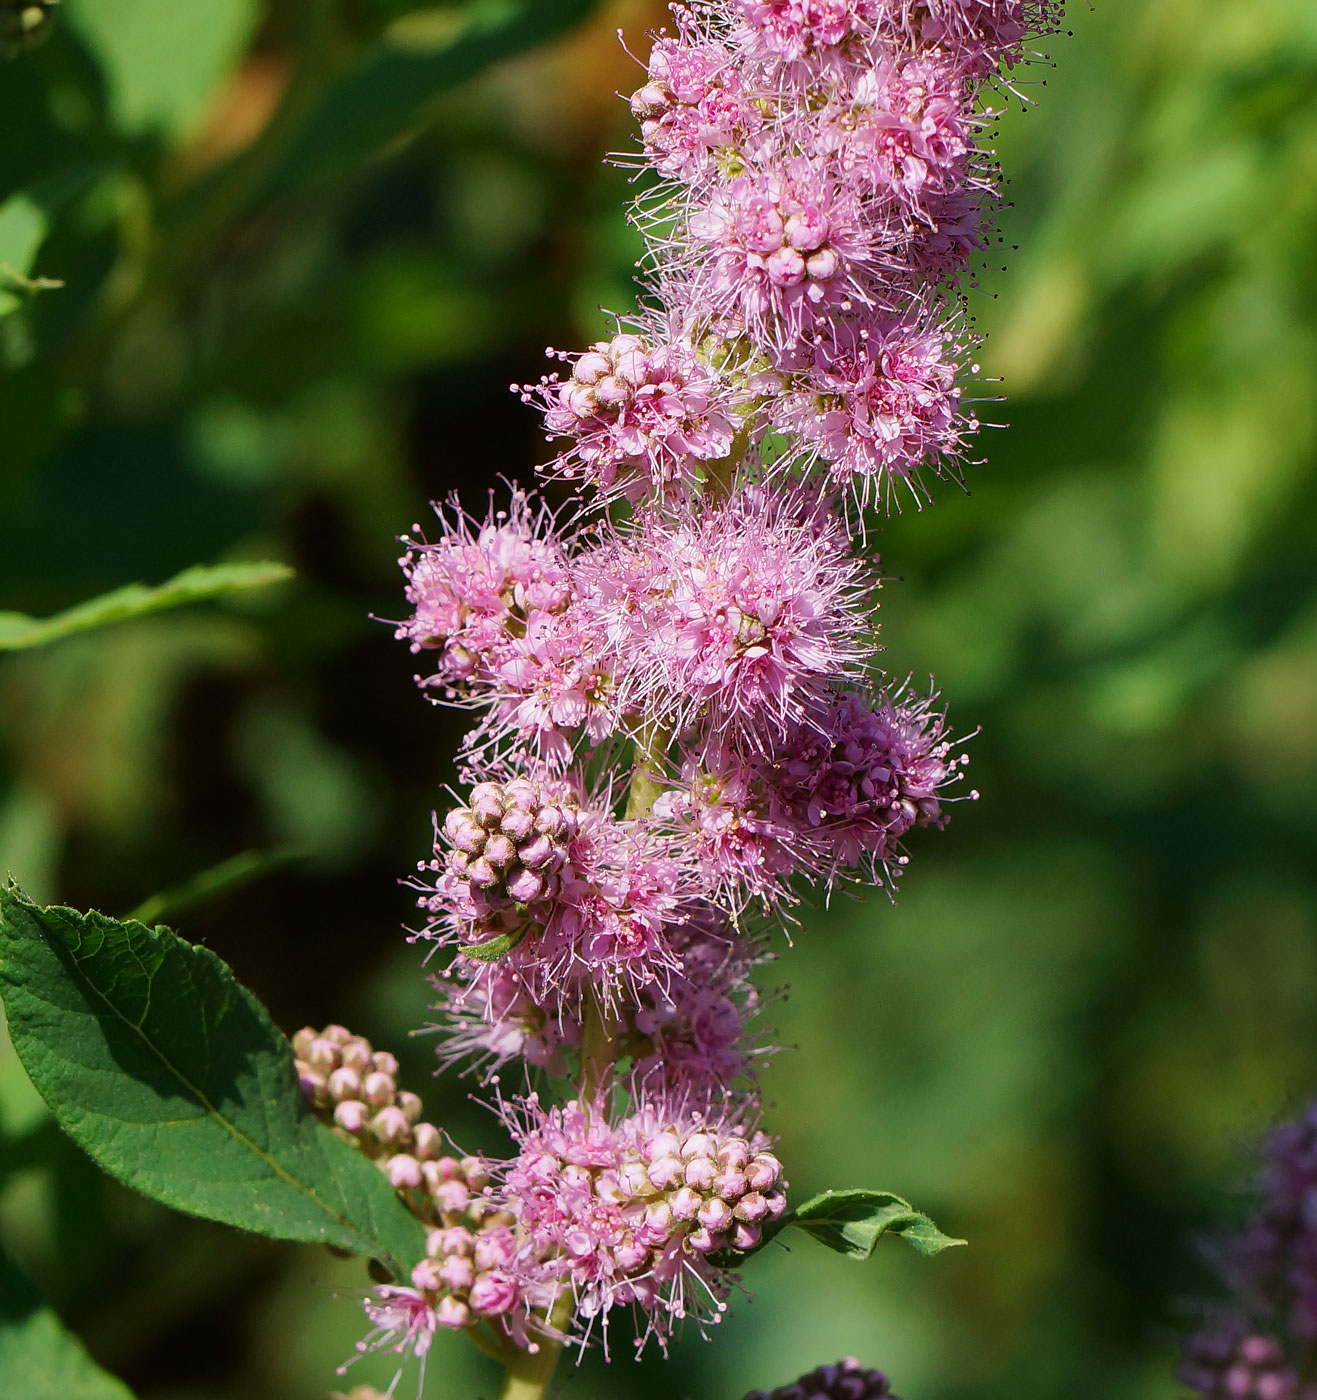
[69,0,260,139]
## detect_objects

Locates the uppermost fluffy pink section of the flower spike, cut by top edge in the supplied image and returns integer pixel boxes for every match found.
[522,0,1061,504]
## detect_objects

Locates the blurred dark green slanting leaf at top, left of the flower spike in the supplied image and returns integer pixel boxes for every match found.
[272,0,592,189]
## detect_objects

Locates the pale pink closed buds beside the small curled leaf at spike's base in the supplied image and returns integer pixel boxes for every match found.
[632,1131,787,1254]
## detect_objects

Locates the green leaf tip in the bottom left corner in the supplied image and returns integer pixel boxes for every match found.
[0,1250,133,1400]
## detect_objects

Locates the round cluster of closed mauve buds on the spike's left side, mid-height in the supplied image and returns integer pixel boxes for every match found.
[444,778,579,909]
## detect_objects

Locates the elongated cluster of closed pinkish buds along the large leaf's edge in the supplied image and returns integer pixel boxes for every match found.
[293,1026,488,1214]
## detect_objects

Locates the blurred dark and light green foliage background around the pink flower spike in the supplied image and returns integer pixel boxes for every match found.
[0,0,1317,1400]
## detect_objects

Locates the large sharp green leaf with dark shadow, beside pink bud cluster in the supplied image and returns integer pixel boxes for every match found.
[0,883,425,1274]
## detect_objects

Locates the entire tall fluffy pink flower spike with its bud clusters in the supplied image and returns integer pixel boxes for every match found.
[323,0,1058,1383]
